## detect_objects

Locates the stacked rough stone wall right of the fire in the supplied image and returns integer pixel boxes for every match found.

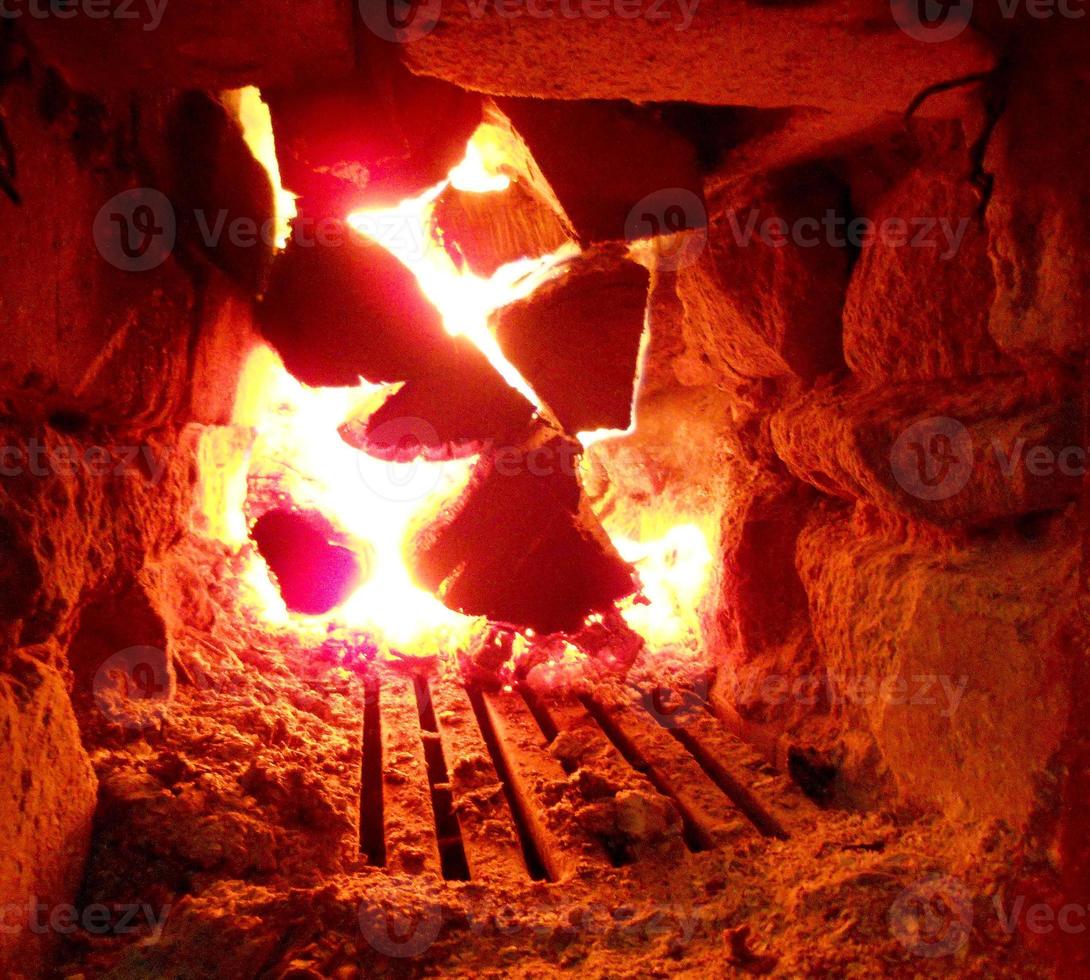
[674,25,1090,845]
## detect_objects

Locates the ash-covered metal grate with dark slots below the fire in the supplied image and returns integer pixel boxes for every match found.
[360,670,812,882]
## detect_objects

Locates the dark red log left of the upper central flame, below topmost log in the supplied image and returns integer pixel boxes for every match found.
[258,218,457,387]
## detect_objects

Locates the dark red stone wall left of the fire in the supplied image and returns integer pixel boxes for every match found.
[0,22,263,976]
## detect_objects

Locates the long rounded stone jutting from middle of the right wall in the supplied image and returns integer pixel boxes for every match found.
[772,375,1080,523]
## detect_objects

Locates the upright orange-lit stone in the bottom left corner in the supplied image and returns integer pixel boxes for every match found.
[0,657,97,977]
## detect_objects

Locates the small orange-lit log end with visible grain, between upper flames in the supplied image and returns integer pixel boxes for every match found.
[432,181,570,279]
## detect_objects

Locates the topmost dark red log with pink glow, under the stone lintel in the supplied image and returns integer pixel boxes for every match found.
[268,49,483,217]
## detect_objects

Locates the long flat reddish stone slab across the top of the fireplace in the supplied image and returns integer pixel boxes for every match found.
[409,0,991,116]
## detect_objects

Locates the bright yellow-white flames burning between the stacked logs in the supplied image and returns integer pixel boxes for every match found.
[205,105,711,655]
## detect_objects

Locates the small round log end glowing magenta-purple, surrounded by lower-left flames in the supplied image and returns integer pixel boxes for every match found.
[250,509,366,616]
